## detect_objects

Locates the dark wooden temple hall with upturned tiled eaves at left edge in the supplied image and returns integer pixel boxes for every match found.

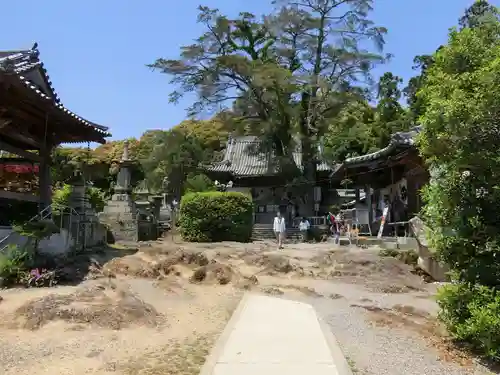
[0,44,110,220]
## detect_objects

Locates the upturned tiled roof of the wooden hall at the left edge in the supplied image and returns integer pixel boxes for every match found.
[0,43,110,137]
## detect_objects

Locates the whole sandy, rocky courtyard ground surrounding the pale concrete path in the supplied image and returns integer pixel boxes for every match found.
[0,239,492,375]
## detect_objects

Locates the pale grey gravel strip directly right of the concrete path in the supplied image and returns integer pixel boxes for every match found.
[309,286,492,375]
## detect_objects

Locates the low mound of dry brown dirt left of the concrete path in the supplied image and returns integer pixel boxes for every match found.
[8,284,160,330]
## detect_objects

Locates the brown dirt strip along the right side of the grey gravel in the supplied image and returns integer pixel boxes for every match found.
[351,305,474,367]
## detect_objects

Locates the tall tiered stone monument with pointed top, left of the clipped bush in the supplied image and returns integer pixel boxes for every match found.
[99,141,138,241]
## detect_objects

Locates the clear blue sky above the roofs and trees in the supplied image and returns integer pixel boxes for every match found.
[0,0,492,139]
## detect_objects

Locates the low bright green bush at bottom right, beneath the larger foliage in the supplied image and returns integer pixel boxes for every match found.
[437,283,500,360]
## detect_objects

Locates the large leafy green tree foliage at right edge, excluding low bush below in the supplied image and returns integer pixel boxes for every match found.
[418,22,500,287]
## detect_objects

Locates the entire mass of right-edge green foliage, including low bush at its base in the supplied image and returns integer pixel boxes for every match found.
[417,10,500,359]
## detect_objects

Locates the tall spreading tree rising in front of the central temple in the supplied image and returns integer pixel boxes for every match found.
[150,0,386,212]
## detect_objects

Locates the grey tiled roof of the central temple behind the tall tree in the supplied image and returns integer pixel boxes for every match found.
[207,136,331,176]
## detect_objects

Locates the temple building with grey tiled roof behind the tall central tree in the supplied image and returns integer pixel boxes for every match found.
[206,136,338,224]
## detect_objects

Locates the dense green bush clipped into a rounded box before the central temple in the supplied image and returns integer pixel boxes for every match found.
[178,192,253,242]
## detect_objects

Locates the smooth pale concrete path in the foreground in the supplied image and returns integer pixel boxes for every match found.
[201,294,352,375]
